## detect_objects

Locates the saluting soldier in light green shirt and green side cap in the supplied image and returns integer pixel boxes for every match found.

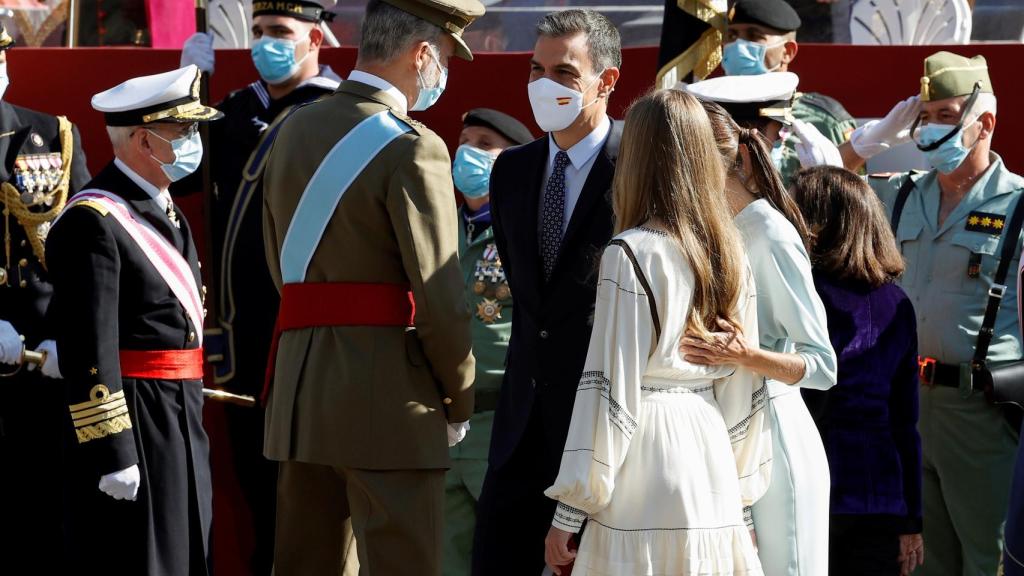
[848,52,1024,576]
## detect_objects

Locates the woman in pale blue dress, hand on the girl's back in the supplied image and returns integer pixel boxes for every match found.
[682,101,837,576]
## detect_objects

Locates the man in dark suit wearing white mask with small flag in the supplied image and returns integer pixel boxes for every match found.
[473,10,622,576]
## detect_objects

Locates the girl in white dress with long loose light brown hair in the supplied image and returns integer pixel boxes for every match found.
[545,90,771,576]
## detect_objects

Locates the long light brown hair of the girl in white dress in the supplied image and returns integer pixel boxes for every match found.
[612,90,744,338]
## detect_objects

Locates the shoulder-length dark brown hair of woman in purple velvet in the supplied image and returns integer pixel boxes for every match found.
[793,166,903,287]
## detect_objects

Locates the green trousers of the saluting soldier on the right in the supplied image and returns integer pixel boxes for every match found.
[914,386,1017,576]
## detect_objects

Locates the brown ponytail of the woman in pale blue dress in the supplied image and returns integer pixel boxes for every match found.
[700,100,808,247]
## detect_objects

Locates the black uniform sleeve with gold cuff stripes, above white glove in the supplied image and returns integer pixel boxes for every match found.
[46,199,138,475]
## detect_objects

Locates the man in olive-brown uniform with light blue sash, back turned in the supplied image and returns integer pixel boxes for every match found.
[263,0,484,576]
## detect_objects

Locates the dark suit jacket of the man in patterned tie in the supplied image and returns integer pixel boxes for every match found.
[489,121,622,471]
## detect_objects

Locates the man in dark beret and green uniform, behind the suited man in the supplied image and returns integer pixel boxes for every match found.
[443,108,534,576]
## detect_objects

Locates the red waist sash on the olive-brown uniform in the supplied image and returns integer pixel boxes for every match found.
[261,282,416,403]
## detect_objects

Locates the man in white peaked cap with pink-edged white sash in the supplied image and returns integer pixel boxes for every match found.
[46,67,220,576]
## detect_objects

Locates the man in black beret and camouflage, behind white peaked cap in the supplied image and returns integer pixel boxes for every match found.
[722,0,857,184]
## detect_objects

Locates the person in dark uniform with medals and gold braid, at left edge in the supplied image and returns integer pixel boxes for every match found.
[0,21,89,574]
